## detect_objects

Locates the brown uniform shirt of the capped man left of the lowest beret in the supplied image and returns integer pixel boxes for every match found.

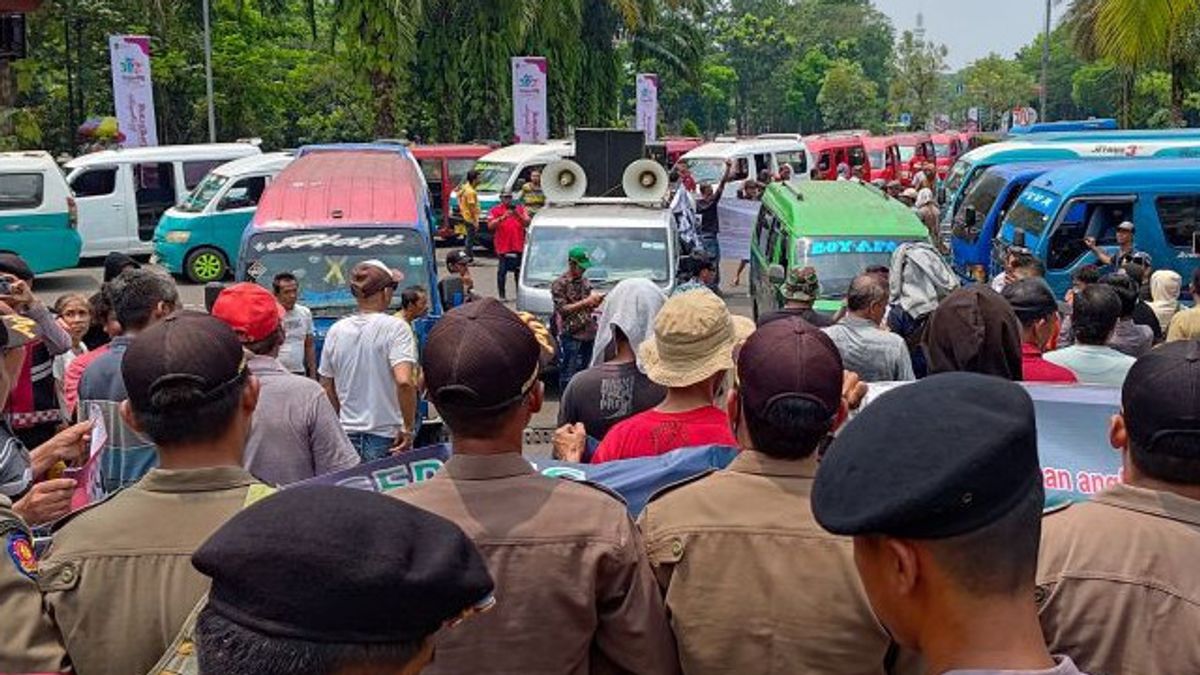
[38,466,257,675]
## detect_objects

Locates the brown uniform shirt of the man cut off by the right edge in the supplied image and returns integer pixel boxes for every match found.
[1037,485,1200,675]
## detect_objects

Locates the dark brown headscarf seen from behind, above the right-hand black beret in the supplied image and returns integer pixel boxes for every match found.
[924,285,1022,381]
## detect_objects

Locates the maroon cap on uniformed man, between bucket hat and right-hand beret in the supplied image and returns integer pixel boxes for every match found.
[738,316,842,417]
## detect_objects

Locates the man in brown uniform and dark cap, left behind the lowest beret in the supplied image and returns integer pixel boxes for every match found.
[38,312,265,675]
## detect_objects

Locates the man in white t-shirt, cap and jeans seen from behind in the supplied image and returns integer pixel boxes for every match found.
[318,259,416,461]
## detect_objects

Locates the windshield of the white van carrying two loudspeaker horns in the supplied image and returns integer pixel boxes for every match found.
[524,226,671,288]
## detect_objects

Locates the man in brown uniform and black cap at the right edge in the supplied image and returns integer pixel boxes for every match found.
[1037,340,1200,675]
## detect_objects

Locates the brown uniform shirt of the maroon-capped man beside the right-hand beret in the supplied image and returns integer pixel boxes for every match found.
[638,450,890,675]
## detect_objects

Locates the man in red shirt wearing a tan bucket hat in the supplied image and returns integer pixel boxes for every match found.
[592,289,737,464]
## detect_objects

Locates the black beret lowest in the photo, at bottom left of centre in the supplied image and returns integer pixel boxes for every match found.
[192,485,493,644]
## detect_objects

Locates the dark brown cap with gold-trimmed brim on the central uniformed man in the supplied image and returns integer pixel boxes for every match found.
[422,298,542,412]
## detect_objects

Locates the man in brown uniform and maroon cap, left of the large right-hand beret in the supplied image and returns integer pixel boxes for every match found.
[638,316,890,674]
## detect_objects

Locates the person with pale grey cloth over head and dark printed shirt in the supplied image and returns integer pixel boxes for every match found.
[558,279,666,440]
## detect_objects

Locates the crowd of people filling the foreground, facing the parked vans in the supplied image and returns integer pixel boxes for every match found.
[0,193,1200,675]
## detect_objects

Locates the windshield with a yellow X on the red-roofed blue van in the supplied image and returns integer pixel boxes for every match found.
[240,228,432,317]
